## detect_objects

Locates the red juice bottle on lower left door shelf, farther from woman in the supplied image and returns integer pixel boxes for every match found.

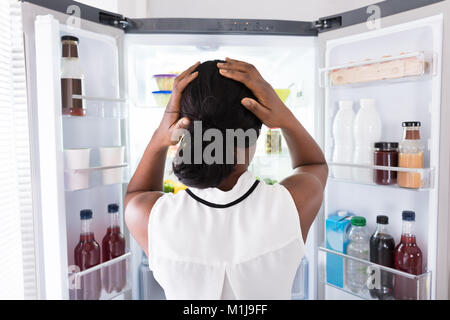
[74,209,102,300]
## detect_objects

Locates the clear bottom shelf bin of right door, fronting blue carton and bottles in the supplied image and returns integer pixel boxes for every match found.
[318,246,432,300]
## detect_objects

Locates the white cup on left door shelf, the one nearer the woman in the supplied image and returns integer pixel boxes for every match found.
[99,146,125,184]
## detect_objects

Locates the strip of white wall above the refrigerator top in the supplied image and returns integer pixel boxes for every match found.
[149,0,382,21]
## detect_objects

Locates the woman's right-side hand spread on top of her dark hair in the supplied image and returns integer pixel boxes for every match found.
[217,58,293,128]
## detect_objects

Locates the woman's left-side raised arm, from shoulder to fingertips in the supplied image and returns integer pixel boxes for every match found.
[125,62,199,256]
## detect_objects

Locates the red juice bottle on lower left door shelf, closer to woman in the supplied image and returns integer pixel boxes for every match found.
[102,203,127,293]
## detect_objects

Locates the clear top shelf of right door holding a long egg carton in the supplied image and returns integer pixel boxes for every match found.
[319,51,437,88]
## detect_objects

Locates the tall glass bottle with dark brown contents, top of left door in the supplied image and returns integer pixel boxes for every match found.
[61,36,86,116]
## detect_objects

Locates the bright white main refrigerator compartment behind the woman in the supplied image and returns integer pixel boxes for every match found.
[125,34,316,298]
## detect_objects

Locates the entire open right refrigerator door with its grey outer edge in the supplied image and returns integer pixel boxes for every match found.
[318,1,450,299]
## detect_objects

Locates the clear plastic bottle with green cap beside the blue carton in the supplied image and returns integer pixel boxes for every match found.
[345,216,369,293]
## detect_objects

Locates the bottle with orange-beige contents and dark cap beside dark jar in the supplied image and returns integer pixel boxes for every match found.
[397,121,424,189]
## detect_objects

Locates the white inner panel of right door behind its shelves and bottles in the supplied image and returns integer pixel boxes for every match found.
[319,16,442,299]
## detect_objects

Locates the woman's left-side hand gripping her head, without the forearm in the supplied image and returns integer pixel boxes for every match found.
[156,62,200,146]
